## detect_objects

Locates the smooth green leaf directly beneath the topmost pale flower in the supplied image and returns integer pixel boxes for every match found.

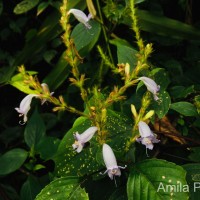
[71,20,101,56]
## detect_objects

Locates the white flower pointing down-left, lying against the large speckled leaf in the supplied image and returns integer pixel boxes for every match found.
[72,126,98,153]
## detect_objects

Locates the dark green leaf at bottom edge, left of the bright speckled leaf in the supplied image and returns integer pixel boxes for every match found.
[20,176,42,200]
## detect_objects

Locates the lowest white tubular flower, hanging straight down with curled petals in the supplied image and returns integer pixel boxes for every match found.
[103,144,126,180]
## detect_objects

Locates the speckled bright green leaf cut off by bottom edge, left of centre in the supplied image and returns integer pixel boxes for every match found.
[35,177,89,200]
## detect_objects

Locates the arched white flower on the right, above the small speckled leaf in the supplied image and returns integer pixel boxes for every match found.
[138,76,160,101]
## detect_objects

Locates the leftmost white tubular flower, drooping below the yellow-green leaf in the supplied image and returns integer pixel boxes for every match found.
[15,94,38,124]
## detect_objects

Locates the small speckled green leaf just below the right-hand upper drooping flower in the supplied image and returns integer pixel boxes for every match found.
[152,90,171,119]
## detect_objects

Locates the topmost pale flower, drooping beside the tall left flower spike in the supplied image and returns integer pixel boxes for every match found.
[68,8,92,29]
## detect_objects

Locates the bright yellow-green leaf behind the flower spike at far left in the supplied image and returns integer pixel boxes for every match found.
[9,71,38,94]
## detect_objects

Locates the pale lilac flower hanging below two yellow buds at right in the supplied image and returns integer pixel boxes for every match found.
[137,121,160,150]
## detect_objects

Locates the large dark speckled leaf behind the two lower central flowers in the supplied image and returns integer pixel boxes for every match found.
[54,110,132,176]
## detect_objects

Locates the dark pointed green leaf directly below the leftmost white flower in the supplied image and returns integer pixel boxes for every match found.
[24,109,46,148]
